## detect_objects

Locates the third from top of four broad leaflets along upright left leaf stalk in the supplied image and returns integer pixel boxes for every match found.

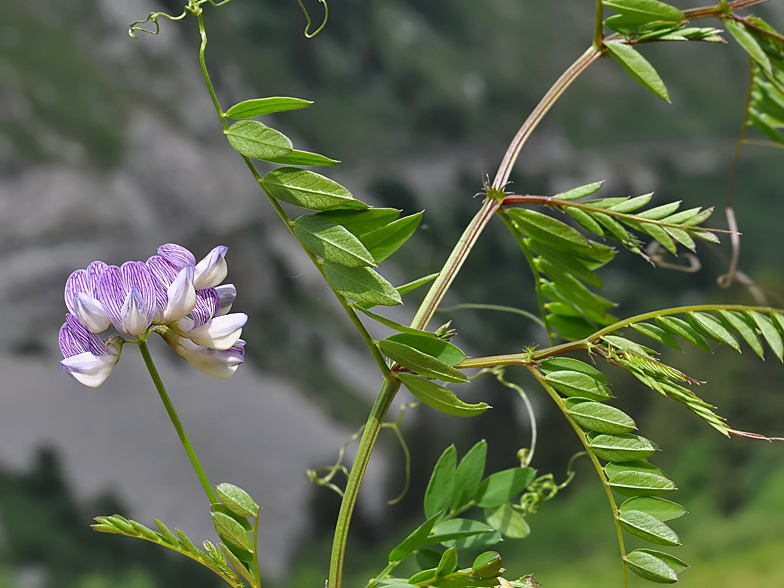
[293,215,376,267]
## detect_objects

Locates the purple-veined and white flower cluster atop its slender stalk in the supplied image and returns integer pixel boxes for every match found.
[60,243,248,387]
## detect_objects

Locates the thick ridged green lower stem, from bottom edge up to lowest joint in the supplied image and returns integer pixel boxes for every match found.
[328,377,400,588]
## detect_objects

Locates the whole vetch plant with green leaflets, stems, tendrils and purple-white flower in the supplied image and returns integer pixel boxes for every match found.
[60,0,784,588]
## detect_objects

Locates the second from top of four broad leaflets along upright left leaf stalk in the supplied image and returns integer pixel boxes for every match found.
[260,167,367,210]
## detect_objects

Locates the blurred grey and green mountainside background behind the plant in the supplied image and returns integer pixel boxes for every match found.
[0,0,784,588]
